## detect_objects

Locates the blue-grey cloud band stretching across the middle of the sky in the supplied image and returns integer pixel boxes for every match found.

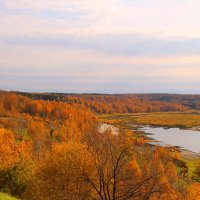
[2,33,200,56]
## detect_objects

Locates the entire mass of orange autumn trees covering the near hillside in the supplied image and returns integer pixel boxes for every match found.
[0,93,199,200]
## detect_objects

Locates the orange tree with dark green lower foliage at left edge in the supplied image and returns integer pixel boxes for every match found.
[0,129,32,196]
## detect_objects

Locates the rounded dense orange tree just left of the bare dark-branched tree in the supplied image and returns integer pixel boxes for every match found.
[25,141,91,200]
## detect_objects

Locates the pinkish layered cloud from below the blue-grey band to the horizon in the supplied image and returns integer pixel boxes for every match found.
[0,42,200,93]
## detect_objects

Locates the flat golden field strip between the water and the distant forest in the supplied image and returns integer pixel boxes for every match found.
[100,111,200,128]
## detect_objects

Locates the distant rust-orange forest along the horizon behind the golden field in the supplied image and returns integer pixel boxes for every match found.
[13,92,189,113]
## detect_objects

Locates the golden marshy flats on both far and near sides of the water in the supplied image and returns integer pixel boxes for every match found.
[100,111,200,181]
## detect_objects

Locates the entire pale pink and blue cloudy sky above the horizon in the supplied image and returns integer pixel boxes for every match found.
[0,0,200,94]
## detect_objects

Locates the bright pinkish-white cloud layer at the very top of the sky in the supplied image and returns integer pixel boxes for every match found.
[0,0,200,38]
